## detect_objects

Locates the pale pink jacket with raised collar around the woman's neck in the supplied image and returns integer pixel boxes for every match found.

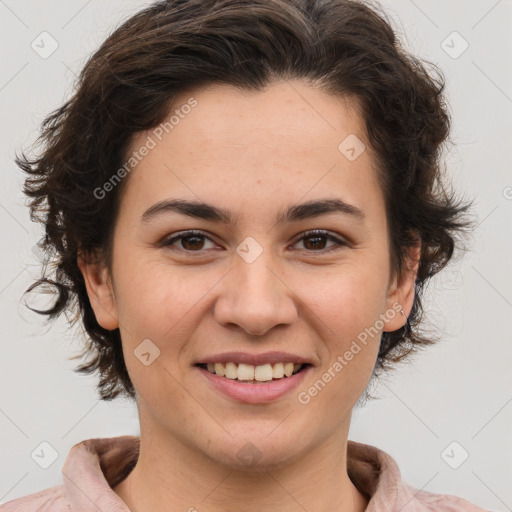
[0,436,485,512]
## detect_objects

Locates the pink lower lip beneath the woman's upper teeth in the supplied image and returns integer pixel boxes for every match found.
[196,366,312,404]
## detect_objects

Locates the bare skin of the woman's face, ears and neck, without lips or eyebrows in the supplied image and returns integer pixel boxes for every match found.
[80,81,419,512]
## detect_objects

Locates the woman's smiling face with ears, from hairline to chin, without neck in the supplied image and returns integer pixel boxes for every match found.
[81,81,414,467]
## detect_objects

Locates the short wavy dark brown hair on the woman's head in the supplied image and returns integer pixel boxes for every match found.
[16,0,470,400]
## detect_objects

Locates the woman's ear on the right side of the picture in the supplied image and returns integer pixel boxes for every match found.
[383,239,421,332]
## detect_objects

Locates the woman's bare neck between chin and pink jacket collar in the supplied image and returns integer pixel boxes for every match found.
[114,418,368,512]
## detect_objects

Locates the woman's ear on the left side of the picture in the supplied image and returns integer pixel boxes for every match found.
[77,250,119,331]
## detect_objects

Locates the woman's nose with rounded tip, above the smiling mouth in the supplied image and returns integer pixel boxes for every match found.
[214,251,297,336]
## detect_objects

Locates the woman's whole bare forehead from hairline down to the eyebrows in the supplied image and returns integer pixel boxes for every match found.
[119,81,379,222]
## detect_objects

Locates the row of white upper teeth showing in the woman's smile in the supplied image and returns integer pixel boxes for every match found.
[202,362,302,382]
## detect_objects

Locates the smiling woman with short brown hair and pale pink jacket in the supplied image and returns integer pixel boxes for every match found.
[2,0,483,512]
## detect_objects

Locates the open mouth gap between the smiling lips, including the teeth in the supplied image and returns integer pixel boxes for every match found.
[195,361,312,384]
